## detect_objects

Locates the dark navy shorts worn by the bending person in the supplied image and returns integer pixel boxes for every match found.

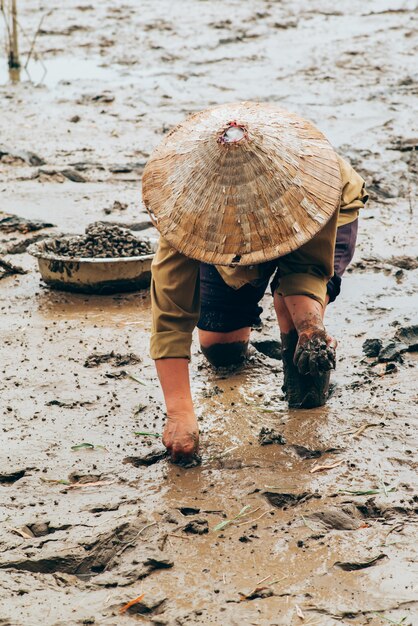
[197,220,358,333]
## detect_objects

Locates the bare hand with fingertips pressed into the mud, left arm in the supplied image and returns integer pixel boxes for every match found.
[163,415,199,463]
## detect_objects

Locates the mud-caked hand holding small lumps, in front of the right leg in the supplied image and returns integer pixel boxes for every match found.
[293,328,337,376]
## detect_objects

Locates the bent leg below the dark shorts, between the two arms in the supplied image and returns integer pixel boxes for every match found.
[199,326,251,367]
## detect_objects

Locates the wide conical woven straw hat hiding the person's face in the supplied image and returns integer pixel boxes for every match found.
[142,102,341,265]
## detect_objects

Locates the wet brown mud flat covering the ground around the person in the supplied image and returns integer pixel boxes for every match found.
[0,0,418,626]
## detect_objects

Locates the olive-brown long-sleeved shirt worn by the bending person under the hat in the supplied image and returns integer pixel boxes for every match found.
[151,157,367,359]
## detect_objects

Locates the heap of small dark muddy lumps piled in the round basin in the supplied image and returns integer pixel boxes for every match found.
[54,222,152,258]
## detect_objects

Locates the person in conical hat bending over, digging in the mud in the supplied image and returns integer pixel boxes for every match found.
[143,102,367,462]
